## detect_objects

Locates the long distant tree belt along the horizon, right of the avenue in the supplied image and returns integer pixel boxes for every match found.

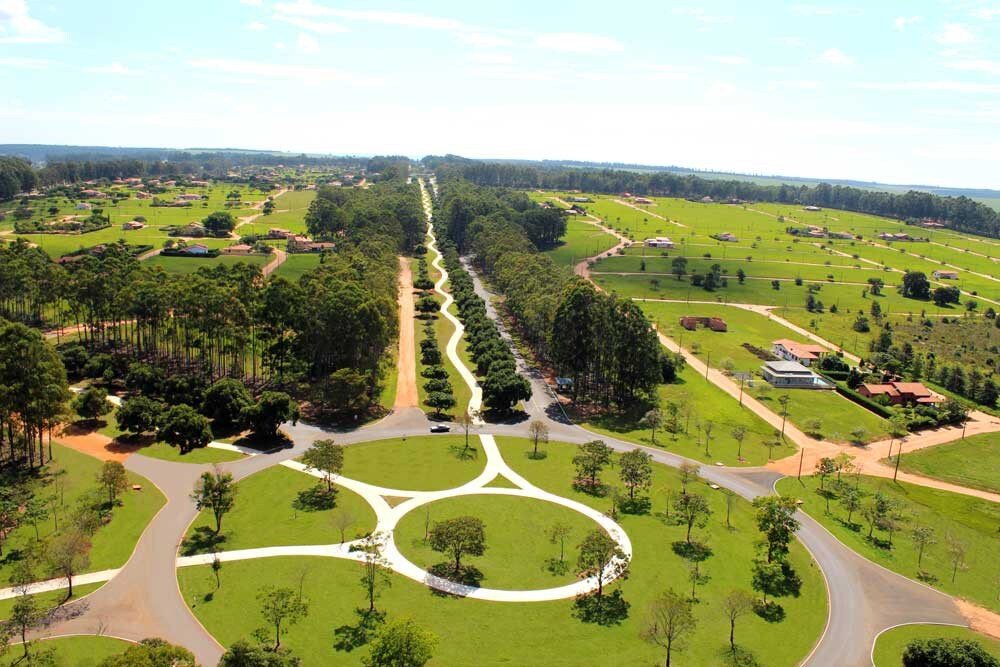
[425,158,1000,238]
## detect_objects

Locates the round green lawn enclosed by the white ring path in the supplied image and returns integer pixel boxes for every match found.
[396,495,600,590]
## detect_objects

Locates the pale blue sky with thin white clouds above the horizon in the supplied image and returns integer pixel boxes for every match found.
[0,0,1000,188]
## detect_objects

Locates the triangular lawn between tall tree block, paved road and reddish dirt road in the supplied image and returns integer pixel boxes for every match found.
[582,368,796,466]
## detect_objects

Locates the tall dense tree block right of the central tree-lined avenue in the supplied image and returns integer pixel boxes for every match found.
[436,173,664,408]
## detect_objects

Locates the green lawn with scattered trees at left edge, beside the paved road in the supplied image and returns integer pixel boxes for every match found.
[0,443,165,582]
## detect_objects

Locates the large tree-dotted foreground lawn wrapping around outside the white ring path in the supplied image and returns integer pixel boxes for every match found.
[178,438,826,667]
